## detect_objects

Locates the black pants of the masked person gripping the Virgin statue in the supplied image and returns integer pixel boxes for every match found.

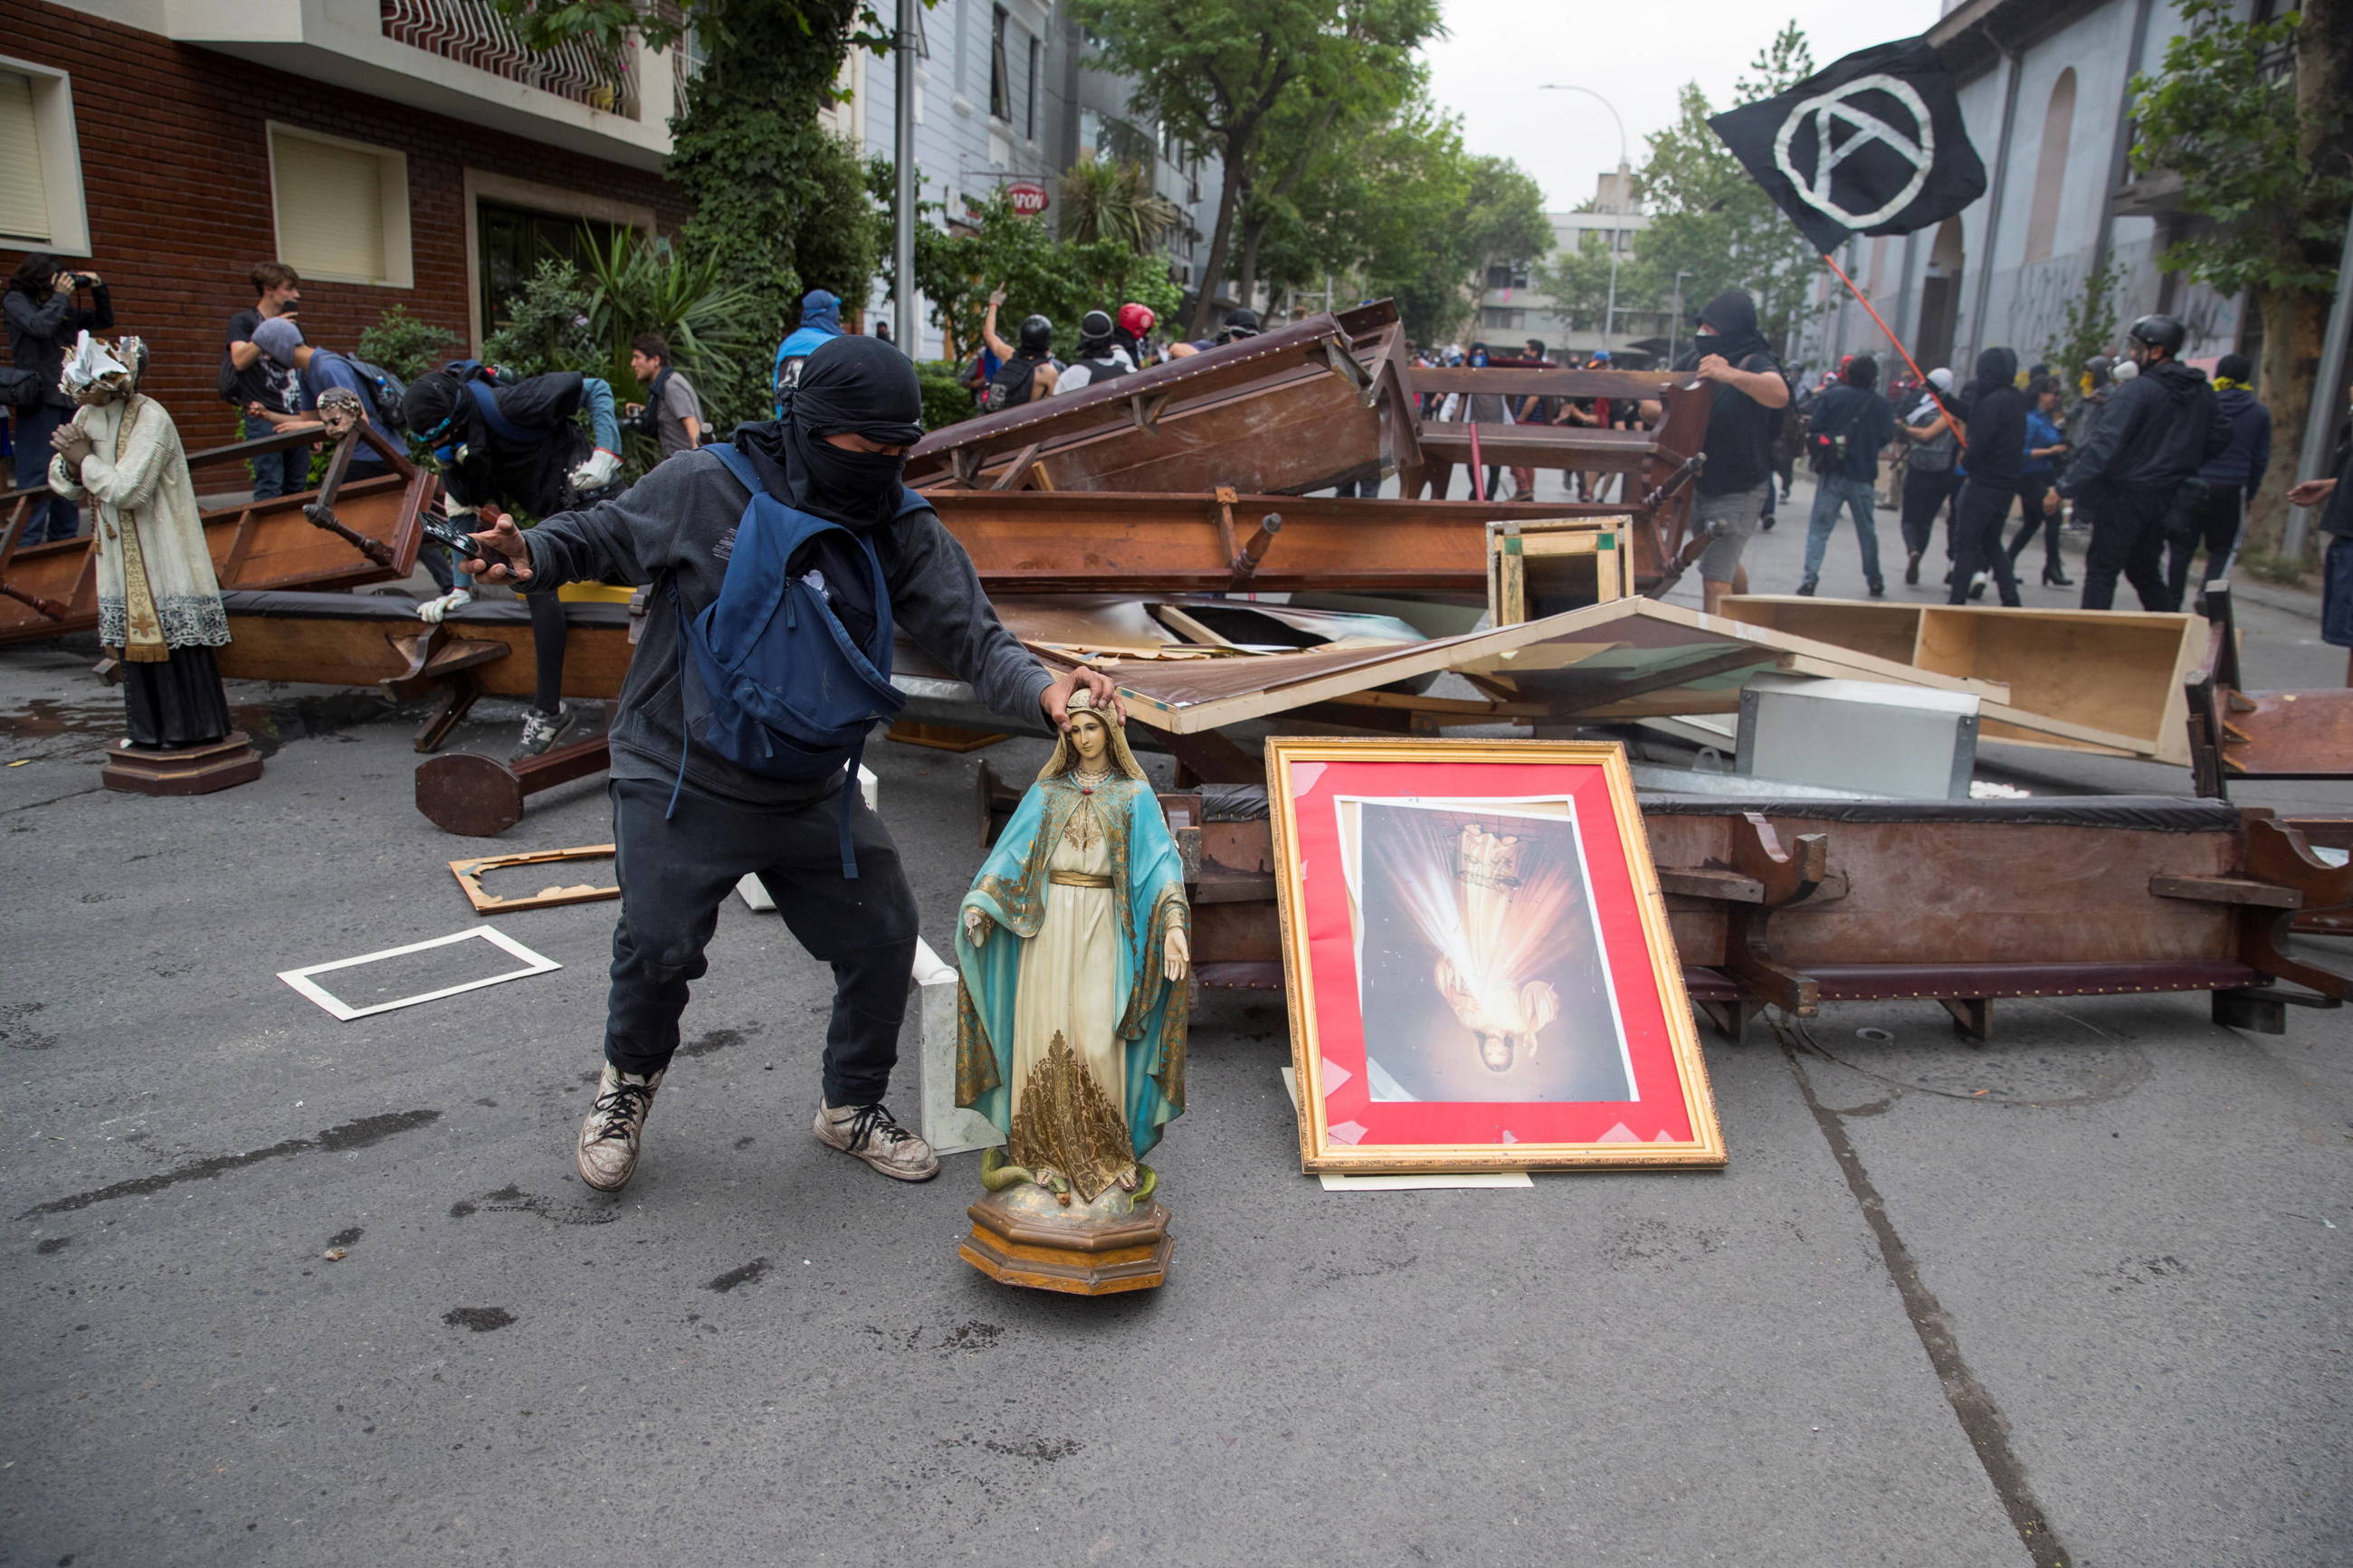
[605,778,918,1105]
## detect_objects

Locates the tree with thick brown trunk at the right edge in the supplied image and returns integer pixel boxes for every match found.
[2132,0,2353,546]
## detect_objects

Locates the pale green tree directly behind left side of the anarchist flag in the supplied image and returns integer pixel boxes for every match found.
[1619,21,1821,348]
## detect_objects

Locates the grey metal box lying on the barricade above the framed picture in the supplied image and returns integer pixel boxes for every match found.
[1737,675,1977,799]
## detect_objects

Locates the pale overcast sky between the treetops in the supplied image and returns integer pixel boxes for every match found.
[1424,0,1941,212]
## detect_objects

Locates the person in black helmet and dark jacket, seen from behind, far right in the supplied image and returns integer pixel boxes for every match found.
[2059,315,2231,612]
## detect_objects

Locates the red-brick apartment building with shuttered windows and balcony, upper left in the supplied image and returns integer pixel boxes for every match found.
[0,0,685,444]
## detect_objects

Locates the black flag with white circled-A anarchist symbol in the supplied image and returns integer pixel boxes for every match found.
[1709,38,1986,254]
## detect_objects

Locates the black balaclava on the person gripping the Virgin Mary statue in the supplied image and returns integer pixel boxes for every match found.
[734,337,922,529]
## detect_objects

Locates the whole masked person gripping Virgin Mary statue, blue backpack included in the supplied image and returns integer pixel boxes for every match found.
[466,337,1118,1192]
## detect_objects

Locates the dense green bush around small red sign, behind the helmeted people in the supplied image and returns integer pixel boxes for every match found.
[915,193,1184,353]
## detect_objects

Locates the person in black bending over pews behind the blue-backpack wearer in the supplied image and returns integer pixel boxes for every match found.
[400,369,621,762]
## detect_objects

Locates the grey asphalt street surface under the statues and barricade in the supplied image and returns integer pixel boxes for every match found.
[0,477,2353,1568]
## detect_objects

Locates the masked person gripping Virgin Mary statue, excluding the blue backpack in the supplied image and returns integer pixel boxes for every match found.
[466,337,1115,1192]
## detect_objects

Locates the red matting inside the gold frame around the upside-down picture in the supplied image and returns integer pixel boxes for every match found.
[1290,759,1699,1150]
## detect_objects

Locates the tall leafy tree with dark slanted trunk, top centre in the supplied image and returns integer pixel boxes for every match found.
[1073,0,1440,331]
